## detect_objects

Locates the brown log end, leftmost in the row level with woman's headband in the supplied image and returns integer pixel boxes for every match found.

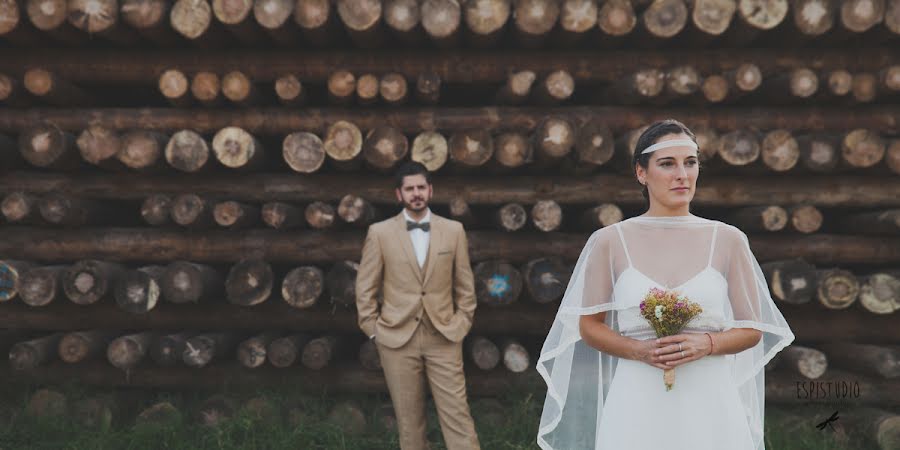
[19,122,81,170]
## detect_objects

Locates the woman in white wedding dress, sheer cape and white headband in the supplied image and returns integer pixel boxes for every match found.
[537,120,794,450]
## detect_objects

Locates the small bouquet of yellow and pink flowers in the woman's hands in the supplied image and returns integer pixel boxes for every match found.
[641,288,703,391]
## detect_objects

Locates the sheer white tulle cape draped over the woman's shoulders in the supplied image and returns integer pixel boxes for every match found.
[537,215,794,450]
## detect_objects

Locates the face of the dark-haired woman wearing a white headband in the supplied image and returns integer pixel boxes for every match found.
[637,134,700,209]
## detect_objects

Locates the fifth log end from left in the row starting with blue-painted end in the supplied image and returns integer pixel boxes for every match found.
[159,261,224,304]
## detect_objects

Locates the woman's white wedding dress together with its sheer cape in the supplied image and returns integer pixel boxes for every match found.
[538,216,794,450]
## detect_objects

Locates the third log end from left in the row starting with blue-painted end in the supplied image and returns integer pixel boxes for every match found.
[62,259,125,305]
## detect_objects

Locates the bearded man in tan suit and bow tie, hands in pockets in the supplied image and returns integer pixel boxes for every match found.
[356,162,480,450]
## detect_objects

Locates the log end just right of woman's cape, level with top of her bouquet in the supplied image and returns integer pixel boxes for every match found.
[761,258,818,305]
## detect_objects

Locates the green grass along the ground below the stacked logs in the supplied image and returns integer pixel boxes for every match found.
[0,387,880,450]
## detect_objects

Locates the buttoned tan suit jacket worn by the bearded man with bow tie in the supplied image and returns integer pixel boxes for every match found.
[356,212,476,348]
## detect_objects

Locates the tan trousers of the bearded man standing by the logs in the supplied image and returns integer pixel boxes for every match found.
[375,314,481,450]
